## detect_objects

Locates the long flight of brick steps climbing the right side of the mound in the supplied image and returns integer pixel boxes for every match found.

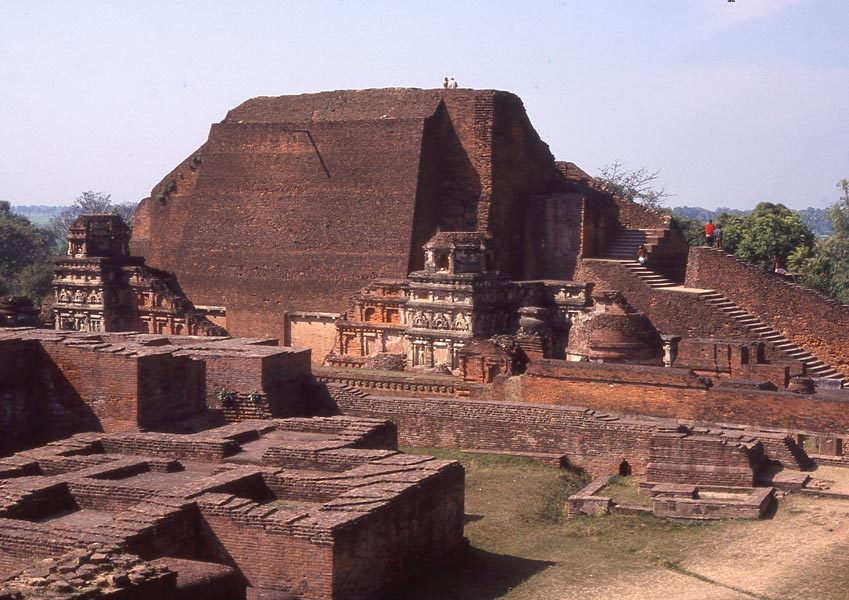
[600,229,849,387]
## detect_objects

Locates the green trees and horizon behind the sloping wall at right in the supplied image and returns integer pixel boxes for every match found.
[670,179,849,302]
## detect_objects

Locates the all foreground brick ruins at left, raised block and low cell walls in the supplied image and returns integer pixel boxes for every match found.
[0,328,465,600]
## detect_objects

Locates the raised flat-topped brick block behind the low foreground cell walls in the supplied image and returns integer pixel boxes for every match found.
[0,329,310,450]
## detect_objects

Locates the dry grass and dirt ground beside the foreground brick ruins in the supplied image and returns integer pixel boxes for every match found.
[385,449,849,600]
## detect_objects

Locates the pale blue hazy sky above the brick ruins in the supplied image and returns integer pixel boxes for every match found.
[0,0,849,208]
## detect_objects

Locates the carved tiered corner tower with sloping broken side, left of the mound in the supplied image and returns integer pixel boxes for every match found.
[53,215,226,335]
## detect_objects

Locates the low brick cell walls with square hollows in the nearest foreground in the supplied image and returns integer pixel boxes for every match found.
[0,417,463,600]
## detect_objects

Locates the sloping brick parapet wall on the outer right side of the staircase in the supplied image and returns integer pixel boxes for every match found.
[686,248,849,373]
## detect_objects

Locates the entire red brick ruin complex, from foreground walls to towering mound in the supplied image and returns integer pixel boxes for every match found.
[0,89,849,600]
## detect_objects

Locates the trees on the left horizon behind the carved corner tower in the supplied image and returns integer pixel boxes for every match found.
[0,192,135,305]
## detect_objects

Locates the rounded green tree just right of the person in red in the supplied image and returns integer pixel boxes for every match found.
[718,202,814,271]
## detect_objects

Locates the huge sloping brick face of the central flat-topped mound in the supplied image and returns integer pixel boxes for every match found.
[133,89,575,338]
